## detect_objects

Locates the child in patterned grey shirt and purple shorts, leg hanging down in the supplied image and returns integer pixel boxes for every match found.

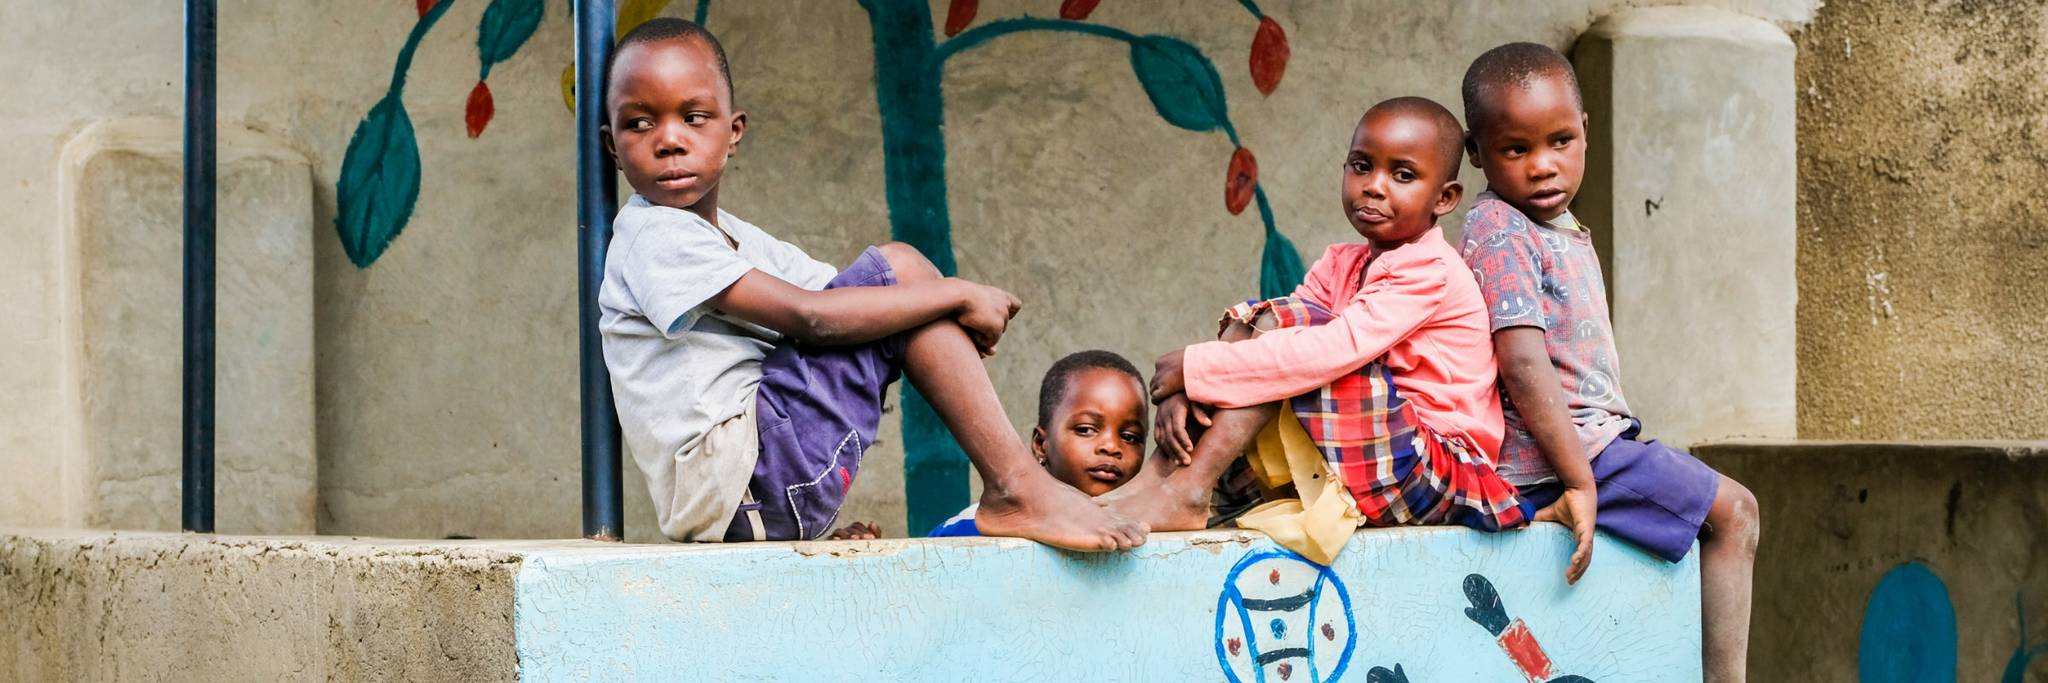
[1460,43,1757,681]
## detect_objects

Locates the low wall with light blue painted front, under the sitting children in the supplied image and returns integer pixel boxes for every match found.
[0,525,1700,681]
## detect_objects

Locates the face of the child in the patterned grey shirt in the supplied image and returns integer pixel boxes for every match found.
[1473,76,1585,222]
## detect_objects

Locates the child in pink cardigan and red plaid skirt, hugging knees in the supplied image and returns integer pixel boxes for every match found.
[1110,96,1526,562]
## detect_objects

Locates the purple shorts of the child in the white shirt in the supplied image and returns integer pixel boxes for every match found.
[725,246,907,541]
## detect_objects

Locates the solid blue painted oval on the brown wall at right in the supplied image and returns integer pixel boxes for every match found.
[1855,562,1956,683]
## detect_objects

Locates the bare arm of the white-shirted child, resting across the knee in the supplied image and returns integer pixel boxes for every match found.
[711,271,1022,355]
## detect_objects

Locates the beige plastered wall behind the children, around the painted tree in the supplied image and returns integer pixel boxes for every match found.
[0,0,1815,539]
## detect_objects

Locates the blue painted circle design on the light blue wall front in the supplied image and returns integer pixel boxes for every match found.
[1217,548,1358,683]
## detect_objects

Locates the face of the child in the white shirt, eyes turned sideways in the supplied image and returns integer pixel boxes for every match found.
[604,39,748,222]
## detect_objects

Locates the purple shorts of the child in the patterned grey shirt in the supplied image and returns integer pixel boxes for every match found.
[1522,425,1720,562]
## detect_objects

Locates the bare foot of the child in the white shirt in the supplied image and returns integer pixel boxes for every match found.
[975,476,1147,552]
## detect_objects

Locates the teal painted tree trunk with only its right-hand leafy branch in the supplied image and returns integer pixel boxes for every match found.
[860,0,1305,531]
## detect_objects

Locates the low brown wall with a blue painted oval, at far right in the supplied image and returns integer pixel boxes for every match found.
[1694,441,2048,683]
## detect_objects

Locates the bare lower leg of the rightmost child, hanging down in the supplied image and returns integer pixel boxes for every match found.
[1700,476,1761,683]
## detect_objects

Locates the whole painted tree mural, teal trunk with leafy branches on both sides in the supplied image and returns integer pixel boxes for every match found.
[336,0,1305,531]
